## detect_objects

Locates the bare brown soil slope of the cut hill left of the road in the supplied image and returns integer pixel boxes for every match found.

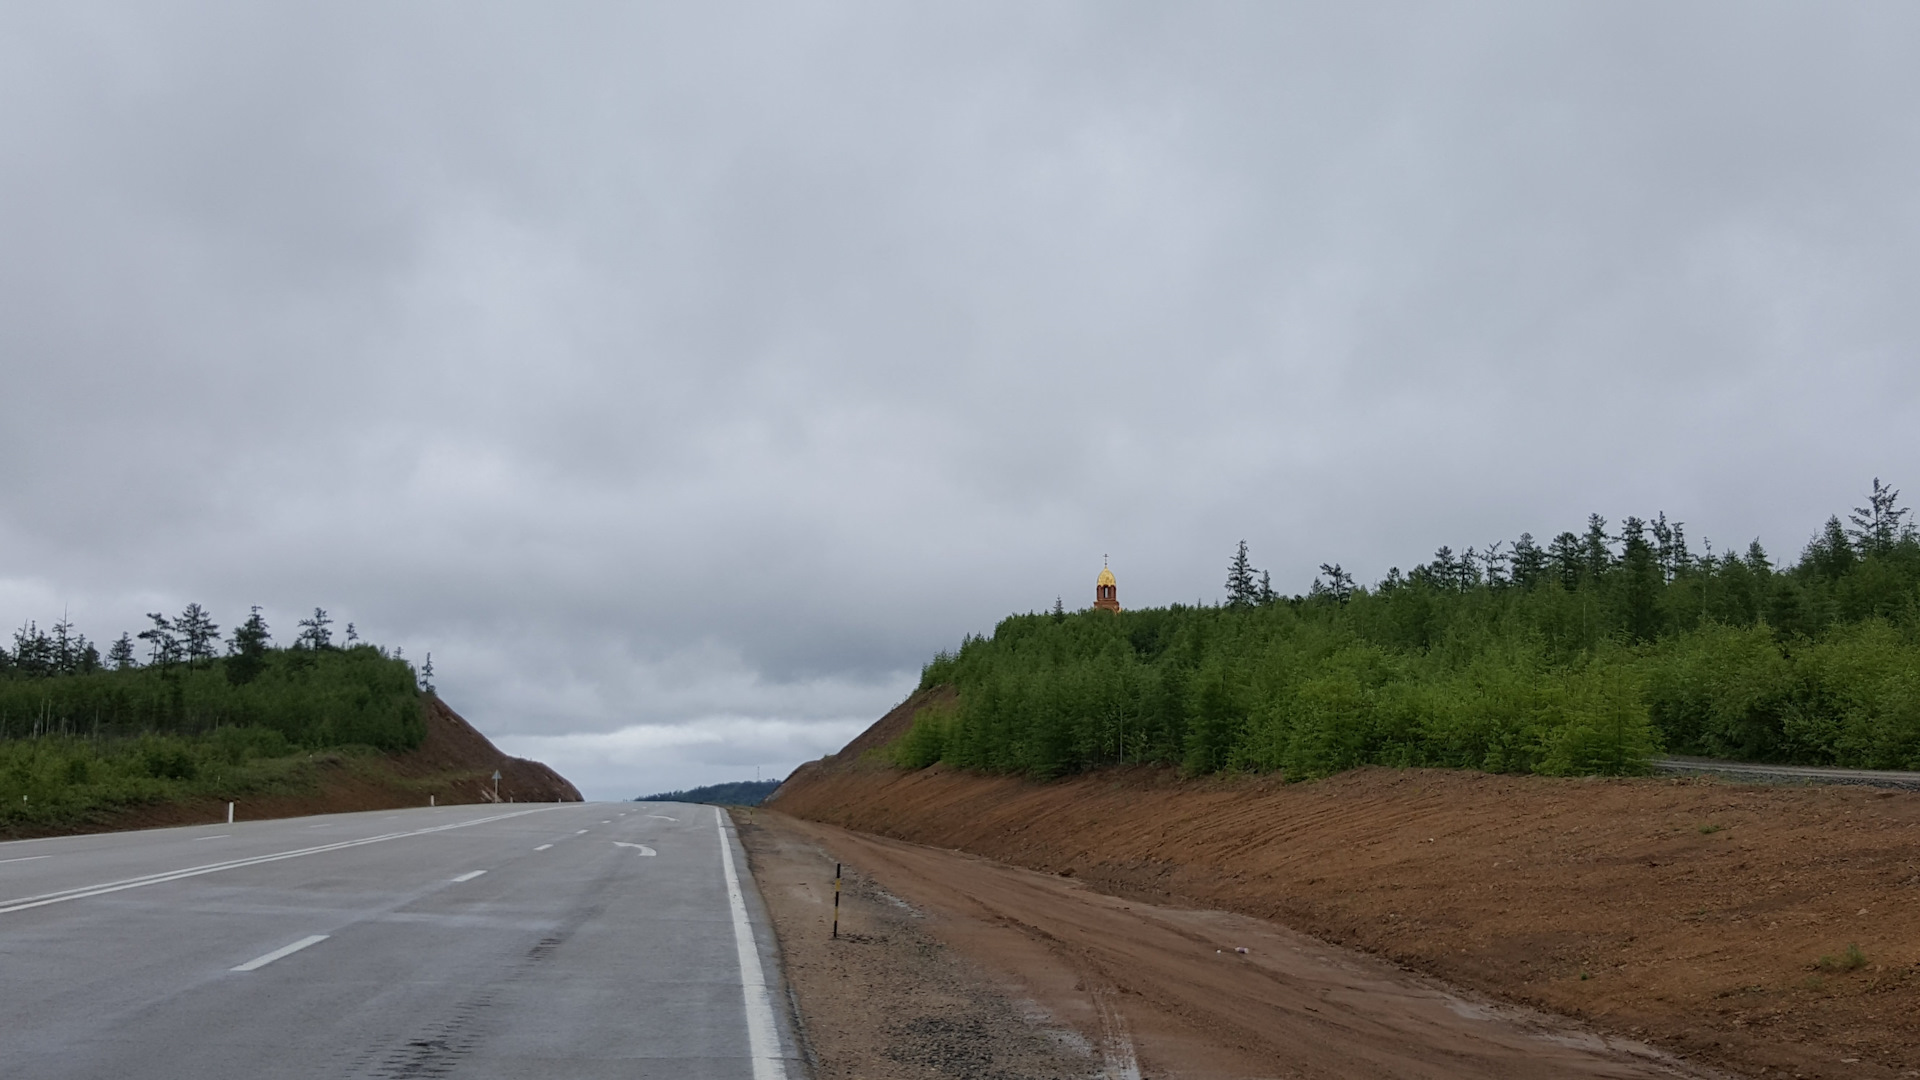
[4,698,580,840]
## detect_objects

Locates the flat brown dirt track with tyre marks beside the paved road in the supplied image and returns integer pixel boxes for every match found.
[749,813,1695,1080]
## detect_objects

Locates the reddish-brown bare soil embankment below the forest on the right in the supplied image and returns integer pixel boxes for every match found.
[772,755,1920,1078]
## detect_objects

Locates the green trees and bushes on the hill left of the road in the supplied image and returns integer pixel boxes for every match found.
[0,603,432,826]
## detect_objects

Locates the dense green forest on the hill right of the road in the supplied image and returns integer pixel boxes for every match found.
[887,479,1920,778]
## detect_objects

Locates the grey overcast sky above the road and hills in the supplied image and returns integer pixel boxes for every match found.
[0,0,1920,798]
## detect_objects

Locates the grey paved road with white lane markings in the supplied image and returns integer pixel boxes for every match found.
[0,803,803,1080]
